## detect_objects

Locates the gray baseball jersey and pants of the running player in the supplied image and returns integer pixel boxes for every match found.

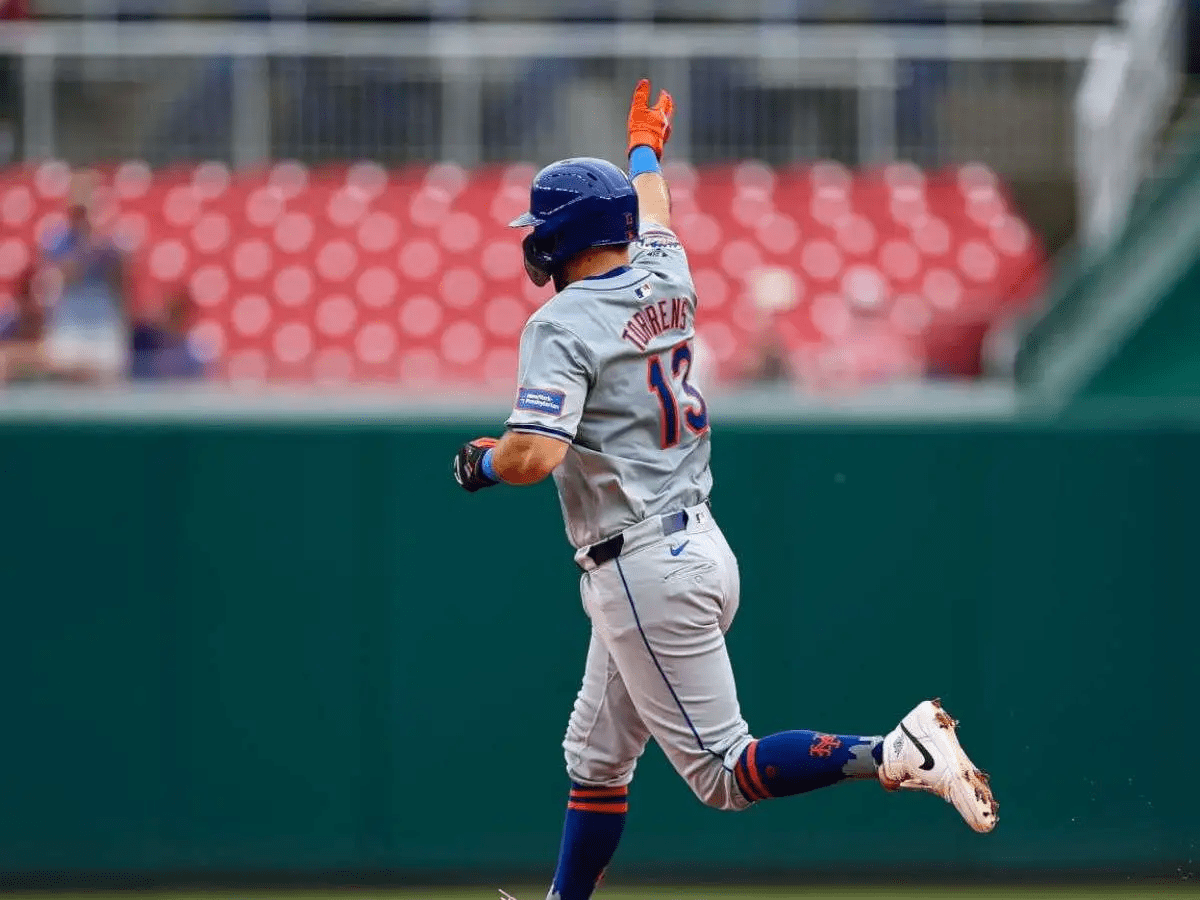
[508,218,752,830]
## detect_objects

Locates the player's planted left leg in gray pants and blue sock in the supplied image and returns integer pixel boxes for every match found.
[548,630,649,900]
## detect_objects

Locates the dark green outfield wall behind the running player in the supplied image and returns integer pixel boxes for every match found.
[0,422,1200,880]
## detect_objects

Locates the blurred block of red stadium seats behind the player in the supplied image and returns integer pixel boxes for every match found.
[0,161,1045,389]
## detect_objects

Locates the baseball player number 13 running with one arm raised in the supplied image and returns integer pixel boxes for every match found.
[454,80,997,900]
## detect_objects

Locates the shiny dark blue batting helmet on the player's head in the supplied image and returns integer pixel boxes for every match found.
[509,156,637,284]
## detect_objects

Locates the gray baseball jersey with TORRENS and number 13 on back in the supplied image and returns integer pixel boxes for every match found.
[506,223,713,547]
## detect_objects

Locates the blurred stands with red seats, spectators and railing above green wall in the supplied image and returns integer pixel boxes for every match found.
[0,0,1200,392]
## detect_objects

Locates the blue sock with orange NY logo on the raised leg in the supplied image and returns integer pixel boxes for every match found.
[733,731,883,800]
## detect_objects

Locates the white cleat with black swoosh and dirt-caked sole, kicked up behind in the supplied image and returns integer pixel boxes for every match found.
[880,700,1000,833]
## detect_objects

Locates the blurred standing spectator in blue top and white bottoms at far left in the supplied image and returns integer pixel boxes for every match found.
[43,172,128,382]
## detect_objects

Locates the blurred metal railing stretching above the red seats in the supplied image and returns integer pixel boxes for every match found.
[0,22,1110,180]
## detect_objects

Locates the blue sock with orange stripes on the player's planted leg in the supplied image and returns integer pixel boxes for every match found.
[547,781,629,900]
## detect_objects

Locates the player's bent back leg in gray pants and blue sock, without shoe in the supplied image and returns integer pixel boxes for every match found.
[584,527,882,809]
